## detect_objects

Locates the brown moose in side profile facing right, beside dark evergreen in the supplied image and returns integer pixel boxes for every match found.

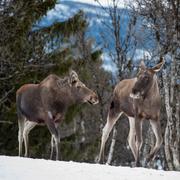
[16,71,99,160]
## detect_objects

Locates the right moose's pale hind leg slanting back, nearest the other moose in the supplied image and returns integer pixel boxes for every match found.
[98,109,122,163]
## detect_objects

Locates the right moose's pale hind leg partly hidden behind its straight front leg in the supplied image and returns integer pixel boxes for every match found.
[128,117,137,161]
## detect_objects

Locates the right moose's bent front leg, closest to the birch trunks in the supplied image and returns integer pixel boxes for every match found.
[147,120,163,162]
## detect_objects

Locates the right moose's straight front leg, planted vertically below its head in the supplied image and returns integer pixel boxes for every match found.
[135,117,143,167]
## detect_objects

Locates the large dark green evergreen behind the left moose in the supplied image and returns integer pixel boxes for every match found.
[0,0,92,157]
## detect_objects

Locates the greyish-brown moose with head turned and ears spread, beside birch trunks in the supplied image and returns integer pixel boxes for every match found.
[98,60,164,166]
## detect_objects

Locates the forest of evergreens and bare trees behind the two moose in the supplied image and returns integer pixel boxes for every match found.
[0,0,180,170]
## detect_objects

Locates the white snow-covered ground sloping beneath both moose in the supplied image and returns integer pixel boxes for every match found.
[0,156,180,180]
